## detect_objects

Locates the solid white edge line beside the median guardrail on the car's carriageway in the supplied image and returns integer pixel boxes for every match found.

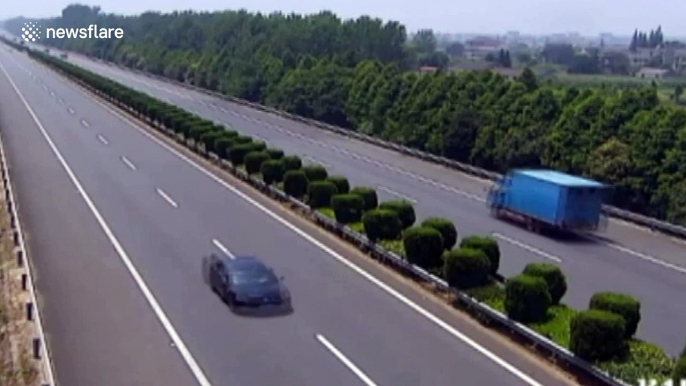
[82,81,543,386]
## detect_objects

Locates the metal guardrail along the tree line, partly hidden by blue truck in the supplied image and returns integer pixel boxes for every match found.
[97,58,686,239]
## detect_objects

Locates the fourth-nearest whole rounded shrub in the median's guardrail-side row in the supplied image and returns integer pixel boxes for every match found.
[404,226,443,268]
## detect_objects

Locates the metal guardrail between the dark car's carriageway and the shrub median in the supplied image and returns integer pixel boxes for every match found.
[41,56,629,386]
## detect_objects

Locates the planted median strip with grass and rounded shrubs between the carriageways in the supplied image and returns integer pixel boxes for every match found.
[20,40,686,384]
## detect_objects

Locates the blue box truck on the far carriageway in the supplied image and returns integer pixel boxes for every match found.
[486,169,611,232]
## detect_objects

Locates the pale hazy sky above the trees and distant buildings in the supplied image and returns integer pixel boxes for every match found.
[0,0,686,36]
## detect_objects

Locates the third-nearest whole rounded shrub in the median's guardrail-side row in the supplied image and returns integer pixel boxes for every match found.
[443,248,491,289]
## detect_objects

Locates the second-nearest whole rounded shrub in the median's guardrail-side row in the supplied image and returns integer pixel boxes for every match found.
[505,275,552,323]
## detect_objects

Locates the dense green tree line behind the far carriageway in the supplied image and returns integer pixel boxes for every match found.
[6,6,686,224]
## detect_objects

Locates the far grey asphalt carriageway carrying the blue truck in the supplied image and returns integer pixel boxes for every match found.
[49,49,686,354]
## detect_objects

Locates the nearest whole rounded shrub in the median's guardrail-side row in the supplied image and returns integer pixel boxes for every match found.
[569,310,626,361]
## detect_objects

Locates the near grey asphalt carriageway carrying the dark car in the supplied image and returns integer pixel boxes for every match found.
[0,43,567,386]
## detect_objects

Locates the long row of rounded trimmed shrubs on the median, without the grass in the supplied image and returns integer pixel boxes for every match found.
[30,48,686,382]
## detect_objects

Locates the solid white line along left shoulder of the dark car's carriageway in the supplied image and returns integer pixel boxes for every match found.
[0,63,212,386]
